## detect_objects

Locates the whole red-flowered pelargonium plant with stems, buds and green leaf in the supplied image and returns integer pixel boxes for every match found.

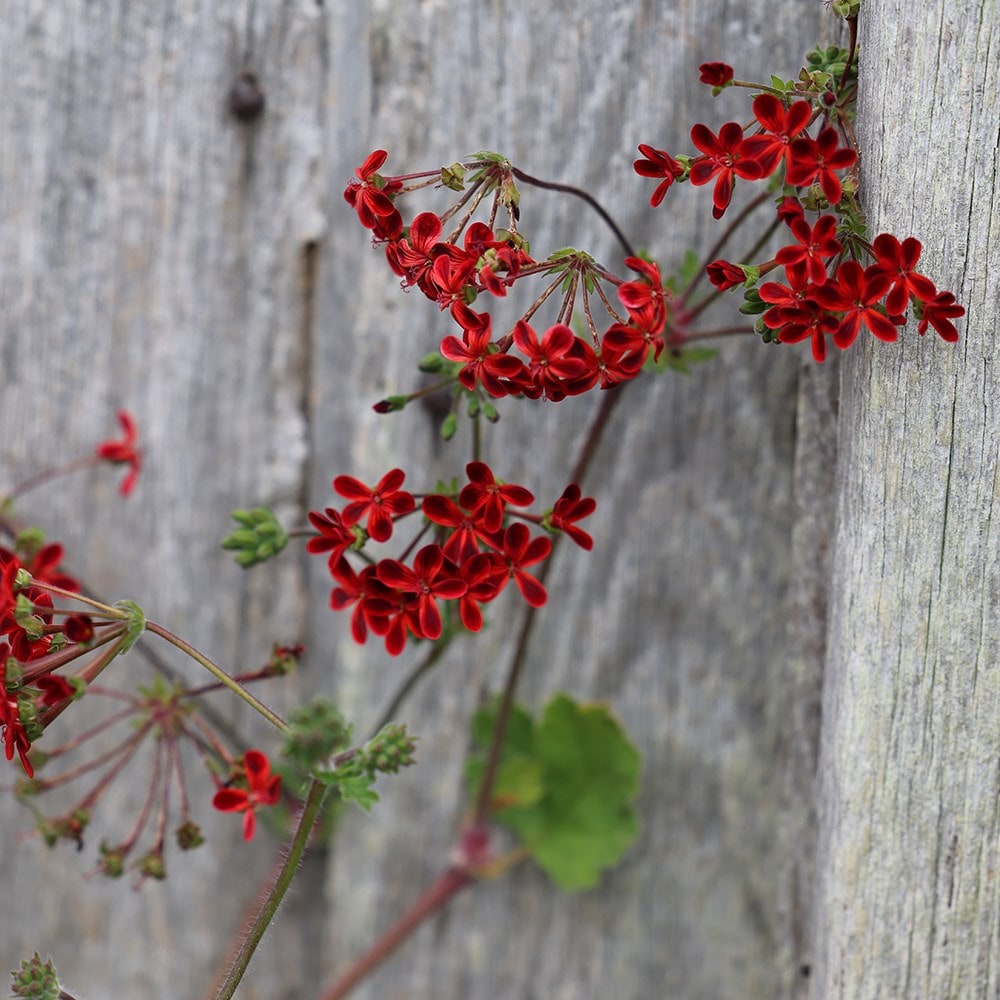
[0,3,964,1000]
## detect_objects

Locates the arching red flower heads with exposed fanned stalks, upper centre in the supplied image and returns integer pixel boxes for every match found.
[344,150,671,410]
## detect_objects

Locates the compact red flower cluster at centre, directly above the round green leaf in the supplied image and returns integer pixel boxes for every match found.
[306,462,596,656]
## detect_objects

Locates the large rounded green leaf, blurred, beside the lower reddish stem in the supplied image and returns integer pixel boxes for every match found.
[468,694,639,890]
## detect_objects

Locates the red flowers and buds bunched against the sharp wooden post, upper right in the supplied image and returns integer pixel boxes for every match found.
[634,63,965,361]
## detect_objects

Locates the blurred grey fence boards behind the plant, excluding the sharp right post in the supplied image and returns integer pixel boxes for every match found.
[0,0,822,1000]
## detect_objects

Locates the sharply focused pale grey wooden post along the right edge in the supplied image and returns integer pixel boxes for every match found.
[814,0,1000,998]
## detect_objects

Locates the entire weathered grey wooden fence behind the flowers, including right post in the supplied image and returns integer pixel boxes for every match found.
[0,0,1000,1000]
